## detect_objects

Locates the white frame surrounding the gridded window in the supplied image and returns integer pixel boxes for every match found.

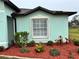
[31,17,49,39]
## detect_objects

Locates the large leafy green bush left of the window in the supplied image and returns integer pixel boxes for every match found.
[15,32,28,47]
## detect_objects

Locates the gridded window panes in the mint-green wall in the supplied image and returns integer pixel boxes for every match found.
[32,18,47,38]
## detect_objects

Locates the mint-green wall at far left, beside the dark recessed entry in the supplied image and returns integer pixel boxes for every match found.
[0,0,12,48]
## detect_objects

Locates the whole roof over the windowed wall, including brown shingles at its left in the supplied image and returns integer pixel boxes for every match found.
[13,6,77,16]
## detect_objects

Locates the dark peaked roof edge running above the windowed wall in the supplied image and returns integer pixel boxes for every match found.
[13,6,77,16]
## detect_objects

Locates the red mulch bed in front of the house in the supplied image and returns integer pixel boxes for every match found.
[0,43,79,59]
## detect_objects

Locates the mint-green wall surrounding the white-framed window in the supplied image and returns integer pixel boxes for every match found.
[16,11,68,43]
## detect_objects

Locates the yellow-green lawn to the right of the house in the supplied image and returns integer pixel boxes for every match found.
[69,28,79,39]
